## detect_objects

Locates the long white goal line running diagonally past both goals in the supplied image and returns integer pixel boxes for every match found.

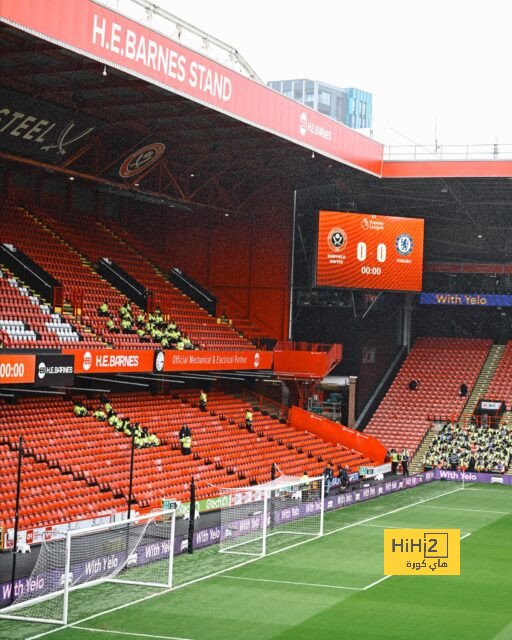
[25,487,464,640]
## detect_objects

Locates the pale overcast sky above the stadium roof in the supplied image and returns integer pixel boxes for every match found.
[164,0,512,145]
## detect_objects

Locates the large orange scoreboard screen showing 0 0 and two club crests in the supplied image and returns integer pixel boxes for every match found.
[316,211,424,291]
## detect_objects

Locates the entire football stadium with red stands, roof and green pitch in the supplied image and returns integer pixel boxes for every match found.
[0,0,512,640]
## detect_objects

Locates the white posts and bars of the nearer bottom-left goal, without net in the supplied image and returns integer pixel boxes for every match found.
[0,509,176,625]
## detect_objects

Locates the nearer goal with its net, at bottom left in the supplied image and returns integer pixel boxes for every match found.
[0,509,176,624]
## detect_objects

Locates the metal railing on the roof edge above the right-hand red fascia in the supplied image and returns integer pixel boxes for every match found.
[384,143,512,161]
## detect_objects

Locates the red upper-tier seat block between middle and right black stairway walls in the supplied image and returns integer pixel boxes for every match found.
[40,214,254,351]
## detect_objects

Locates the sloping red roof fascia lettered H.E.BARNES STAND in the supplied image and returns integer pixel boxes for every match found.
[0,0,383,176]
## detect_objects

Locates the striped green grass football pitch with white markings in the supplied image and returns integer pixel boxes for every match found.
[0,481,512,640]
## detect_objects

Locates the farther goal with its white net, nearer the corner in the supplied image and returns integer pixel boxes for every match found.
[220,476,325,556]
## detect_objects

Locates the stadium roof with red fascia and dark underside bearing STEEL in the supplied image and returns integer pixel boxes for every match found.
[0,0,512,262]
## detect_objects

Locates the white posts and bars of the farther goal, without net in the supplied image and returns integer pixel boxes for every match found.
[219,475,325,558]
